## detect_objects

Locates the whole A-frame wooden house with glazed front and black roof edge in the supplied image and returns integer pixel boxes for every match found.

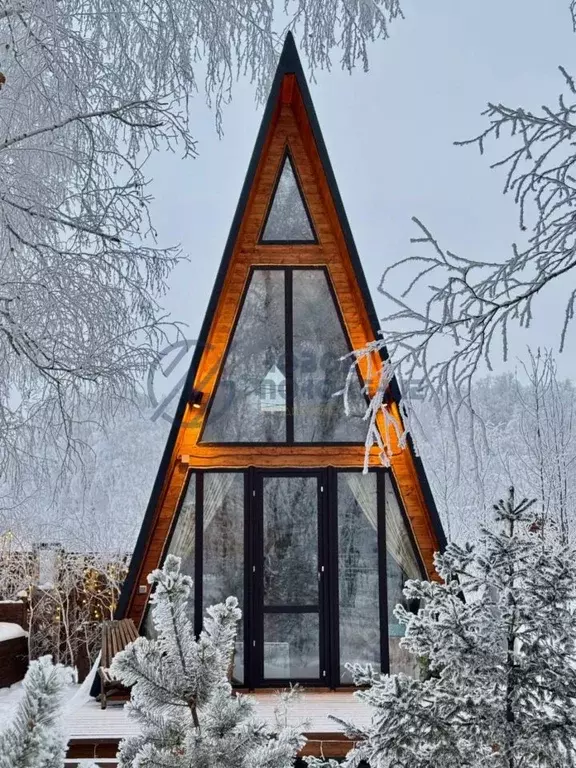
[117,35,444,689]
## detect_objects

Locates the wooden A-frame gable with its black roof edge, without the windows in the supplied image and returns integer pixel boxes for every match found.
[118,35,444,624]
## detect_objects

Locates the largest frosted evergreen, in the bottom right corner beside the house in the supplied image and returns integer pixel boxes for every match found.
[328,489,576,768]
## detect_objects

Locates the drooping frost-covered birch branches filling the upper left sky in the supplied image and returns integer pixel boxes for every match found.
[0,0,401,488]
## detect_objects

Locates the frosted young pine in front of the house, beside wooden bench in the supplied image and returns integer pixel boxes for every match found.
[111,555,305,768]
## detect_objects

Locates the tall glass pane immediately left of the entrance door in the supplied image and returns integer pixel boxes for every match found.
[202,472,244,683]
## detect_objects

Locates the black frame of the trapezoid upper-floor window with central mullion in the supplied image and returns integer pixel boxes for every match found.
[198,264,368,448]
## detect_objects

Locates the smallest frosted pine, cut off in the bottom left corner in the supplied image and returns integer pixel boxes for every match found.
[0,656,86,768]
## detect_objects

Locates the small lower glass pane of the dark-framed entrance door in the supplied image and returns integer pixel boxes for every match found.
[264,613,320,680]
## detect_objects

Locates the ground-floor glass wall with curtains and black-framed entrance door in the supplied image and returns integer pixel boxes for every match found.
[151,469,422,686]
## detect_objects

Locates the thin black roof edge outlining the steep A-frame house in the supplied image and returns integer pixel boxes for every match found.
[116,32,446,618]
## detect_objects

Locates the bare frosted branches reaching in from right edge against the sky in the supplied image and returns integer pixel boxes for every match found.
[360,57,576,462]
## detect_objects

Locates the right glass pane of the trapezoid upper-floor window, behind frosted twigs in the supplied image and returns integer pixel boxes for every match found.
[293,269,366,443]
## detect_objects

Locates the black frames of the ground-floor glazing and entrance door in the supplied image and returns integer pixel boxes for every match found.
[155,466,426,689]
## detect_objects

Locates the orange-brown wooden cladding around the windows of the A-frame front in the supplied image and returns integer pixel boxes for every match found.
[128,75,439,624]
